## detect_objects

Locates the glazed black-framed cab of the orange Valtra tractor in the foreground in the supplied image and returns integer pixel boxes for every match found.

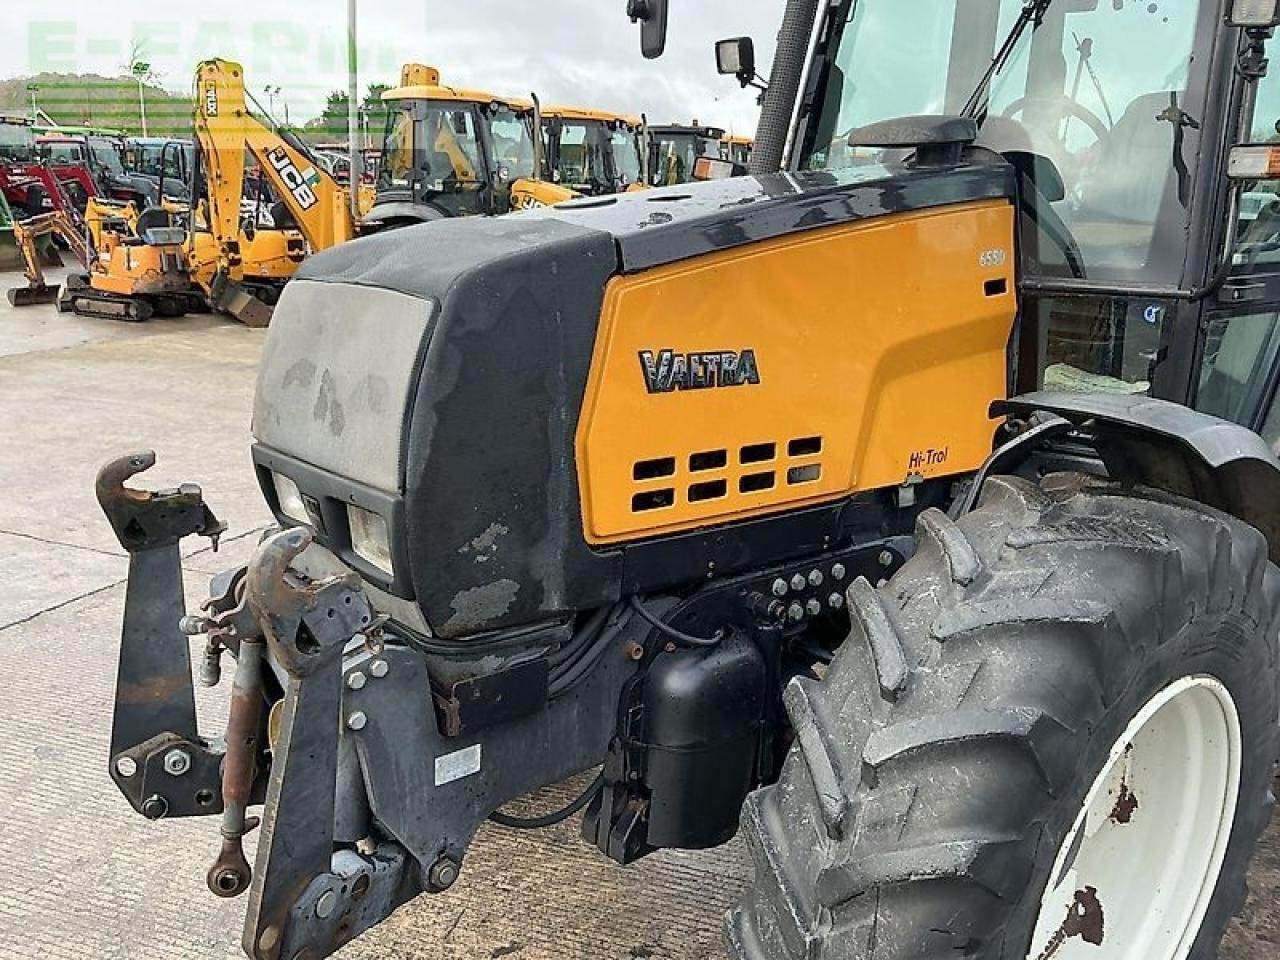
[722,0,1280,455]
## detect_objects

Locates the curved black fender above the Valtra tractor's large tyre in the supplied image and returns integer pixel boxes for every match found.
[991,392,1280,563]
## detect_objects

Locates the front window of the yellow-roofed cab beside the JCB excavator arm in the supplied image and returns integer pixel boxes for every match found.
[378,100,486,215]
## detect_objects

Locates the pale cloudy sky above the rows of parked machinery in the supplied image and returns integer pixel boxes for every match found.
[0,0,782,133]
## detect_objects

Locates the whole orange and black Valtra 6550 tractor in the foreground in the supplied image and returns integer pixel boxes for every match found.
[97,0,1280,960]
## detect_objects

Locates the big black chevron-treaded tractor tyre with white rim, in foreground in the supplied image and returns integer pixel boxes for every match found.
[728,475,1280,960]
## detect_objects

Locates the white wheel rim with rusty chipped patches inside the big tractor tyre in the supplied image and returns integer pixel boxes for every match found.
[1027,676,1242,960]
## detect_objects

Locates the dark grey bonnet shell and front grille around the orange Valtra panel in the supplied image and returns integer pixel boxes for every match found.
[253,155,1014,637]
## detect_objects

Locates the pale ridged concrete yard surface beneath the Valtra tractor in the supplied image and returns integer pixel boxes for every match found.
[0,264,1280,960]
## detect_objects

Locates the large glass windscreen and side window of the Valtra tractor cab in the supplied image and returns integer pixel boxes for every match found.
[800,0,1207,283]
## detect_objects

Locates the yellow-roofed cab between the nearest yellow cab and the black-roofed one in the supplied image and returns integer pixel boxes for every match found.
[541,106,649,197]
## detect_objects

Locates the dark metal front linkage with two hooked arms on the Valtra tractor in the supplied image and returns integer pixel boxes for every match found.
[97,453,649,960]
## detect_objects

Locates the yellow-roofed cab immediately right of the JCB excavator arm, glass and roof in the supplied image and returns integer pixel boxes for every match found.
[366,64,550,227]
